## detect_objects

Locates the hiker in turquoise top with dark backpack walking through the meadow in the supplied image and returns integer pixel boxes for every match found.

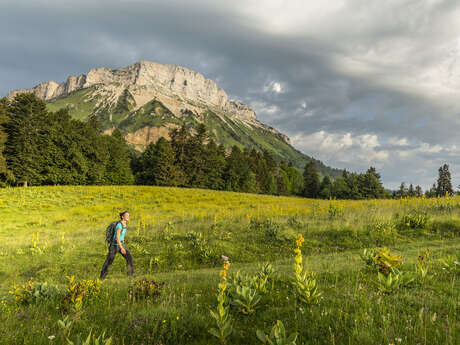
[99,211,133,280]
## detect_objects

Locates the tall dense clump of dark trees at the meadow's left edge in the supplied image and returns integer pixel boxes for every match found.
[0,94,134,186]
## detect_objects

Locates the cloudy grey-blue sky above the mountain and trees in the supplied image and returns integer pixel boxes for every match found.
[0,0,460,189]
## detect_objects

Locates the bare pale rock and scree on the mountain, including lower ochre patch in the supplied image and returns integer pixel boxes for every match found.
[8,61,290,145]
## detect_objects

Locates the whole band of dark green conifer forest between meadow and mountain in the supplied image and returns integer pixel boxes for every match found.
[0,94,452,199]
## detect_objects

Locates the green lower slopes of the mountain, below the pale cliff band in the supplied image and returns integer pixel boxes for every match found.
[47,85,342,178]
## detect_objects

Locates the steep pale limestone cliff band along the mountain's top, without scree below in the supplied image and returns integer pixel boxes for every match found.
[8,61,256,120]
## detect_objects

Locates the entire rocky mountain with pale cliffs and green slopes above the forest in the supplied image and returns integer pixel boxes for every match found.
[8,61,341,177]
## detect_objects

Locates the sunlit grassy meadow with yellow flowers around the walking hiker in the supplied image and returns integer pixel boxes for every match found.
[0,186,460,345]
